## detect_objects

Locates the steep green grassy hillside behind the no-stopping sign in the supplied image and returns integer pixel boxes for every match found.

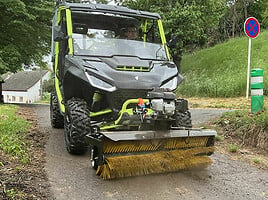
[177,31,268,97]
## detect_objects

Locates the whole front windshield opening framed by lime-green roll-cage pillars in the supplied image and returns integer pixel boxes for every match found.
[72,12,168,60]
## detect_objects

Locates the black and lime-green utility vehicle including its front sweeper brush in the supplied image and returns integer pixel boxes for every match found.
[50,2,216,179]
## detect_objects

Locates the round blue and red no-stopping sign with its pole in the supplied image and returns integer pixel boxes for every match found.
[244,17,260,99]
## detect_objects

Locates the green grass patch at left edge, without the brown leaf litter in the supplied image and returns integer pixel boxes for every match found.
[0,105,30,164]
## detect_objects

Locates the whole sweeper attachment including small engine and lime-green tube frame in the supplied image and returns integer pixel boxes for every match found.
[86,94,217,179]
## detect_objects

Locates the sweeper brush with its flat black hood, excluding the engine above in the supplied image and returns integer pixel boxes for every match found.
[87,129,216,179]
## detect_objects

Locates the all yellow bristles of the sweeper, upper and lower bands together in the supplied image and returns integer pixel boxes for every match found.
[96,136,215,179]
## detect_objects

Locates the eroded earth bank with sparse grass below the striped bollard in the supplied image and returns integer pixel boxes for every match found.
[214,103,268,169]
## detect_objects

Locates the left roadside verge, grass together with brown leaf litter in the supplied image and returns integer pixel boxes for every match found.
[0,104,53,200]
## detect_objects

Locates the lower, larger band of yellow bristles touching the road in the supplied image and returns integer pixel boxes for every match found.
[96,147,214,179]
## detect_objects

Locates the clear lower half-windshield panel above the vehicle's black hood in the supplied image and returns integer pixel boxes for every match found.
[73,30,167,60]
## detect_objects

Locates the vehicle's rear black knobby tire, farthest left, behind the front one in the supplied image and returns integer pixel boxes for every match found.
[50,91,64,128]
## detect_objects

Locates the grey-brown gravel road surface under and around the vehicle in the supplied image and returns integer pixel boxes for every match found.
[34,106,268,200]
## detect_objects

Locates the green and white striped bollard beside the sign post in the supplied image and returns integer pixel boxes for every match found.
[250,68,264,114]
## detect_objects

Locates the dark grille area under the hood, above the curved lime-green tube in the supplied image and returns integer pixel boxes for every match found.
[108,90,148,110]
